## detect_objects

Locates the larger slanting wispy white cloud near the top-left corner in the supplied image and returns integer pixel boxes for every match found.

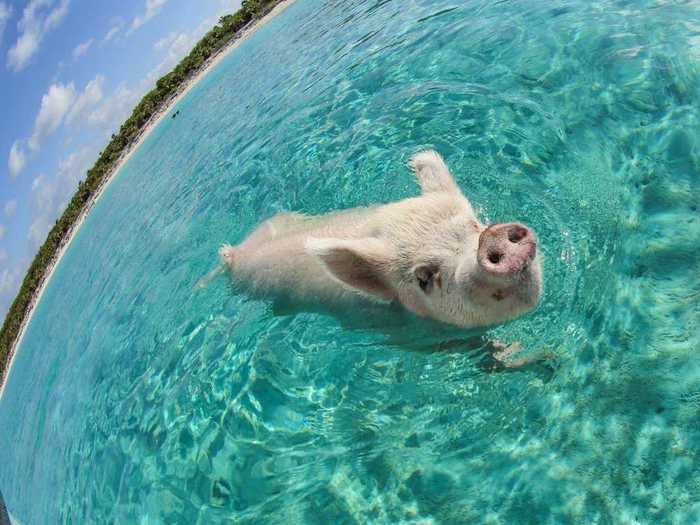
[7,0,70,71]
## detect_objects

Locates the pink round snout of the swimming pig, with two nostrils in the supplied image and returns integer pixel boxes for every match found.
[477,222,537,276]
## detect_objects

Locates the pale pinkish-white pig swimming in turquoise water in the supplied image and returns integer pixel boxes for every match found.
[219,150,543,328]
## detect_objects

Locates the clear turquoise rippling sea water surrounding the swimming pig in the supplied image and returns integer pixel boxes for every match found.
[0,0,700,524]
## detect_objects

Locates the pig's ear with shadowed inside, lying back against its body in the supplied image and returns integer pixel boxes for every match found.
[306,238,395,301]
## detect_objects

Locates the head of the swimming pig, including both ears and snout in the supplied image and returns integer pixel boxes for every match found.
[307,151,542,328]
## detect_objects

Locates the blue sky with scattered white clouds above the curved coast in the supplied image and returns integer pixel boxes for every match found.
[0,0,241,318]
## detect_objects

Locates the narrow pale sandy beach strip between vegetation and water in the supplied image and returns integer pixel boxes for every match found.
[0,0,295,399]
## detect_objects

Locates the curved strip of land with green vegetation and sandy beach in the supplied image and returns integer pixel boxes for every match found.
[0,0,294,386]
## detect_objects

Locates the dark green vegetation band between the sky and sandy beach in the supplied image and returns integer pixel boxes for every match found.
[0,0,280,379]
